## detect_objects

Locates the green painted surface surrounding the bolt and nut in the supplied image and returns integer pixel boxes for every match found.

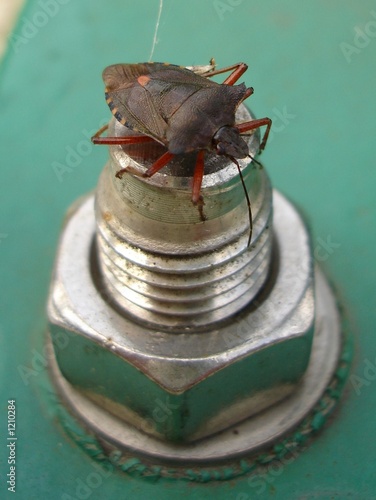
[0,0,376,500]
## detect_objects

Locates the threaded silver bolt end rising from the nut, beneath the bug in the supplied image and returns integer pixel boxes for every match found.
[96,108,272,332]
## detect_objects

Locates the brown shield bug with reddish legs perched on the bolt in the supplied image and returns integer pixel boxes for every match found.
[92,61,272,245]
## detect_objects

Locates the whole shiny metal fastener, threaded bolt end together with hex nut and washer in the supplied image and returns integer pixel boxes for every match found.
[48,108,339,460]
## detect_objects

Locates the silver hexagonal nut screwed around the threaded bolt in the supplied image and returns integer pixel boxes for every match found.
[48,192,315,441]
